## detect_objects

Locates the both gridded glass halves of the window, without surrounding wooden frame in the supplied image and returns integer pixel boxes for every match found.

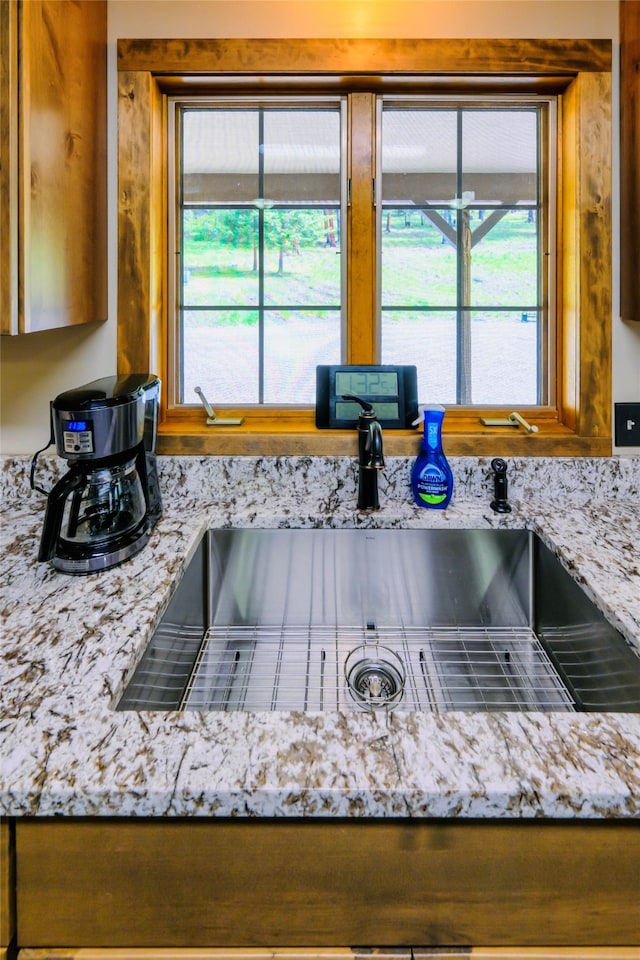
[169,96,555,407]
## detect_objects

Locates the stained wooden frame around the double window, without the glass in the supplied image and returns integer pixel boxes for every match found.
[118,40,612,456]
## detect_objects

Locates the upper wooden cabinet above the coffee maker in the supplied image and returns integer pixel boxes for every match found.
[0,0,107,334]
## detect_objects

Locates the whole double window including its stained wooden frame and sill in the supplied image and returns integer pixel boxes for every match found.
[119,40,611,455]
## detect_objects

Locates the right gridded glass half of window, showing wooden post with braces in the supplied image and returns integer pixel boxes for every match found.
[379,103,546,405]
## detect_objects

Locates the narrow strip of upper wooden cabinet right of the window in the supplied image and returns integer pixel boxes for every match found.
[620,0,640,321]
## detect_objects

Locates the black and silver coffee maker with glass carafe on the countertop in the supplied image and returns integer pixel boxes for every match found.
[32,373,162,574]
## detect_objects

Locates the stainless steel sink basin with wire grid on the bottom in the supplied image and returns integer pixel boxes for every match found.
[118,529,640,712]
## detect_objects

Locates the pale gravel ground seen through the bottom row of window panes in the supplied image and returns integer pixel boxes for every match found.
[184,318,537,406]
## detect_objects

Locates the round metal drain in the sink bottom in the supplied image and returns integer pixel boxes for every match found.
[344,643,405,710]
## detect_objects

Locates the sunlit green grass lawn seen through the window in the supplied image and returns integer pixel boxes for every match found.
[184,211,538,325]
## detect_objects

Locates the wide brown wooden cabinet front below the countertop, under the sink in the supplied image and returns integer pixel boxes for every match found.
[11,818,640,948]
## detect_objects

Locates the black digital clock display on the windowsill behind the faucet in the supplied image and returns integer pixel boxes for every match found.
[316,364,418,430]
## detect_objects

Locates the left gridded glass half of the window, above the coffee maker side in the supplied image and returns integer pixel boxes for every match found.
[176,101,343,405]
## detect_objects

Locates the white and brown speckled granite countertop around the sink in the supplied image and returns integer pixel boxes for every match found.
[0,458,640,818]
